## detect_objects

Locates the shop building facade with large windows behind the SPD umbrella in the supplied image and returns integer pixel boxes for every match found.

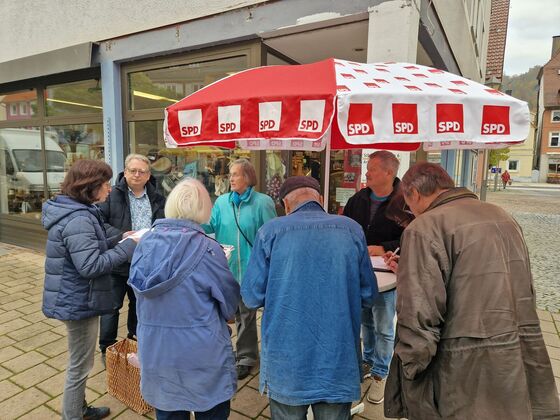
[0,0,490,248]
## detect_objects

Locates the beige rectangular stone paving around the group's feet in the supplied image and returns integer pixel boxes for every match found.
[0,233,560,420]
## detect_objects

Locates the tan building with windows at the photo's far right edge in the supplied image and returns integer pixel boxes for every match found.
[535,35,560,184]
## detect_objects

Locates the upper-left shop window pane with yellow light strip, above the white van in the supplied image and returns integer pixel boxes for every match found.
[45,80,103,116]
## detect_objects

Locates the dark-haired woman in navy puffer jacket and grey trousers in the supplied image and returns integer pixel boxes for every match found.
[42,160,136,420]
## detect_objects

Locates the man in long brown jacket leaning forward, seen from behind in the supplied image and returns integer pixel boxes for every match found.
[385,163,560,420]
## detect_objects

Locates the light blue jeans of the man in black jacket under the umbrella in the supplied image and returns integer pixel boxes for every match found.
[362,290,396,378]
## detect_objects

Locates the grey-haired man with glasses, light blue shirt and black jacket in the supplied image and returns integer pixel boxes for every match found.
[99,154,165,364]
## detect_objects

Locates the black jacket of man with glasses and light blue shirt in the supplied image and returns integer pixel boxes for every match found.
[99,172,165,276]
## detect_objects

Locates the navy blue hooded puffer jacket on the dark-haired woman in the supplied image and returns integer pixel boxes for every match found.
[42,195,136,321]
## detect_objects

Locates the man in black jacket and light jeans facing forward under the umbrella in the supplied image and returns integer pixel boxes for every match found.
[343,150,403,404]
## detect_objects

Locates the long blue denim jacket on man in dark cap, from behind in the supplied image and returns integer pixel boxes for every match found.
[241,201,377,405]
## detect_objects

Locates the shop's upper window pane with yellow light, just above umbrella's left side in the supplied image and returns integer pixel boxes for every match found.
[128,55,248,110]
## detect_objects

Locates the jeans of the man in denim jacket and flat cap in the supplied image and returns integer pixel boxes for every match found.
[270,399,352,420]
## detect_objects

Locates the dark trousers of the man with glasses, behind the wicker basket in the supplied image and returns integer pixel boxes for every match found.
[99,274,138,352]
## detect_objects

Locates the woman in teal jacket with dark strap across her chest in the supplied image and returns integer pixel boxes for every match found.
[203,159,276,379]
